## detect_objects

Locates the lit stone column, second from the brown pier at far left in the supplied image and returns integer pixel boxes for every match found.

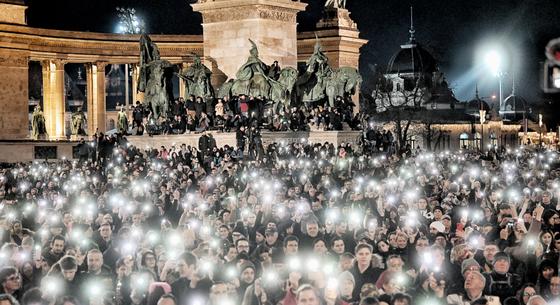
[86,62,107,135]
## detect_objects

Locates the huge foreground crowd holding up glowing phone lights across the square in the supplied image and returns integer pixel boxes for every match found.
[0,134,560,305]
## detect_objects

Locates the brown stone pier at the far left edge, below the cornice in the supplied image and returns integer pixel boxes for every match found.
[0,52,29,140]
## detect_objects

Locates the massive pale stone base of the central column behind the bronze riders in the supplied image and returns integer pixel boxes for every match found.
[192,0,307,88]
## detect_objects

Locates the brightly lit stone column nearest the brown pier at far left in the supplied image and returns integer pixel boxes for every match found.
[41,59,66,140]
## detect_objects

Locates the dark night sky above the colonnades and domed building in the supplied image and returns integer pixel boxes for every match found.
[28,0,560,104]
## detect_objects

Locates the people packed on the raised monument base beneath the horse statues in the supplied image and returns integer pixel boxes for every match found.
[128,95,363,135]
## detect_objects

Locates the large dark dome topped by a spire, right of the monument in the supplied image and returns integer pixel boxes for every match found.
[387,41,438,73]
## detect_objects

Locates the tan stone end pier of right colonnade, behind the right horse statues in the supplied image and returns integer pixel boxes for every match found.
[298,8,368,112]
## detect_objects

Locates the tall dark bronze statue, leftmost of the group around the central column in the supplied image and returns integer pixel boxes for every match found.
[138,34,174,121]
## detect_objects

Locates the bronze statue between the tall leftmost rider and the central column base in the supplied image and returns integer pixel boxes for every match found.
[178,54,214,100]
